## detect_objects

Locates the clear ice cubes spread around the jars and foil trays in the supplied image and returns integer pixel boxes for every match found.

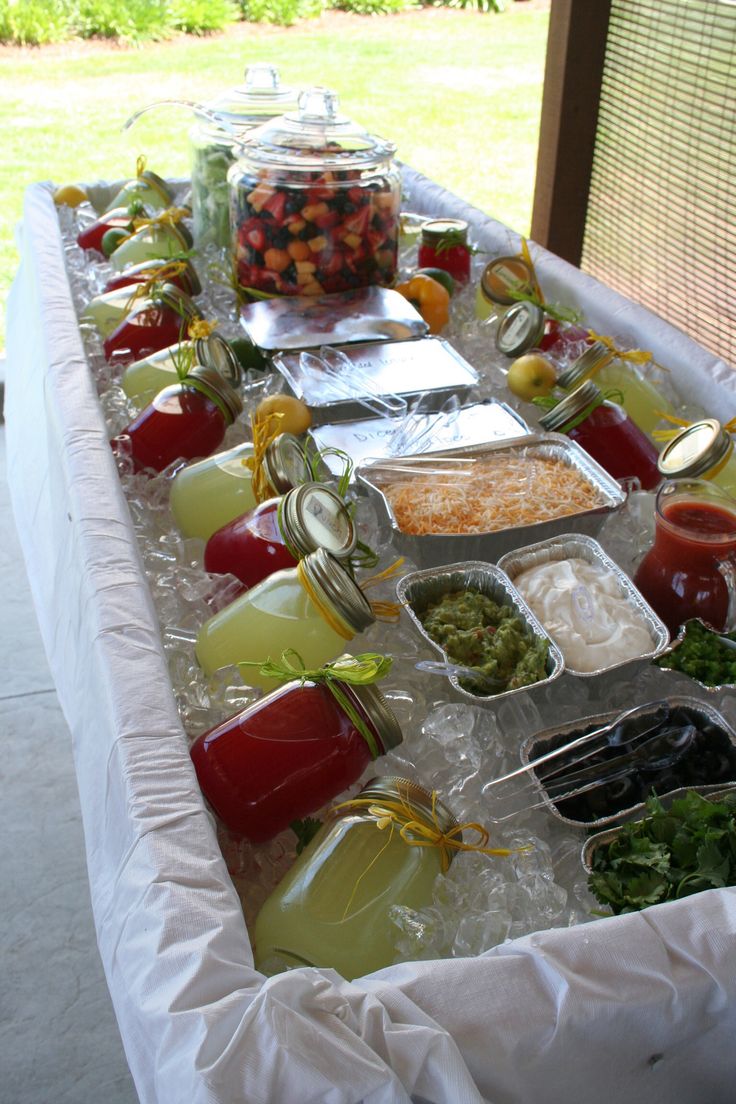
[60,194,729,960]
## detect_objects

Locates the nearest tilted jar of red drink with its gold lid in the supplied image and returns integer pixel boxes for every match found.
[191,656,402,843]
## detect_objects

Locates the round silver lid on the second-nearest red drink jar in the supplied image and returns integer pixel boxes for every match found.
[278,482,358,560]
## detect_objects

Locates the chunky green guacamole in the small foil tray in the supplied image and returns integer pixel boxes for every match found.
[419,590,548,694]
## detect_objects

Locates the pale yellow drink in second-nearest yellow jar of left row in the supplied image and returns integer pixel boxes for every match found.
[195,553,354,690]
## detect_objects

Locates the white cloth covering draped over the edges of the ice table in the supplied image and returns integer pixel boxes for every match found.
[7,169,736,1104]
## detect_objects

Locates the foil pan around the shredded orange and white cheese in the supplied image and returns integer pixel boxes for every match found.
[356,433,626,567]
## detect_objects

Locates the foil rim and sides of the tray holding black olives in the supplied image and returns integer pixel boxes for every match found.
[521,696,736,831]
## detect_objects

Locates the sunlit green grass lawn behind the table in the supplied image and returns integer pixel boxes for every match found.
[0,4,548,346]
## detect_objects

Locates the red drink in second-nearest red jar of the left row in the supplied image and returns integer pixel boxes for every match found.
[204,498,297,586]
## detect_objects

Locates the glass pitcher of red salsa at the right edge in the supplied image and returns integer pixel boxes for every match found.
[633,479,736,634]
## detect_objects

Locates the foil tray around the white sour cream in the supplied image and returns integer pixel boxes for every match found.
[499,533,670,678]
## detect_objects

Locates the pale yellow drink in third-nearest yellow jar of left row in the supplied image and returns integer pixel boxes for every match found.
[169,442,256,541]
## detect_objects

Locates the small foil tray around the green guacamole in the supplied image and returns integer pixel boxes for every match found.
[396,562,565,705]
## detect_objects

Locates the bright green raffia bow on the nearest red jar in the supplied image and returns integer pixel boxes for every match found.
[237,648,392,758]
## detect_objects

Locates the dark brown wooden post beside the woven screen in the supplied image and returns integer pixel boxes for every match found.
[532,0,611,265]
